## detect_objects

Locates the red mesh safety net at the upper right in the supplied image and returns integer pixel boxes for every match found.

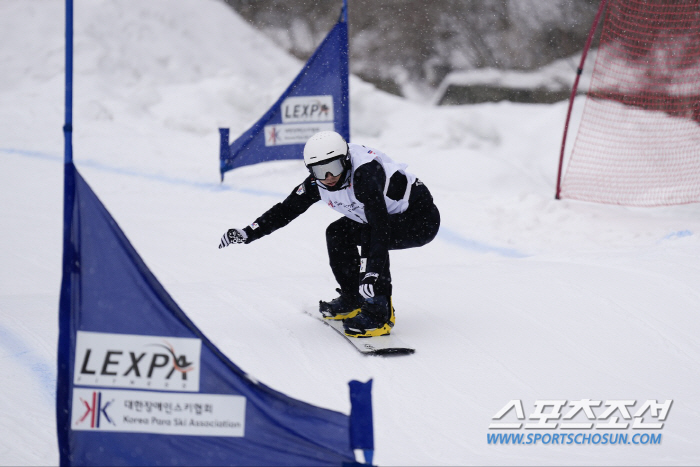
[560,0,700,206]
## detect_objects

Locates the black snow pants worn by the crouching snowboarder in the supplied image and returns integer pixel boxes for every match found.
[326,182,440,296]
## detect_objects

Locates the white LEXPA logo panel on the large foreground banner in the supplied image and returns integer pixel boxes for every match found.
[73,331,202,392]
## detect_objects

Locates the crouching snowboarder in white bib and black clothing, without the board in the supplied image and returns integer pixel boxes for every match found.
[219,131,440,337]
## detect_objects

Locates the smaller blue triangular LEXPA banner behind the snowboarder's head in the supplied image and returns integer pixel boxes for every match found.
[220,1,350,180]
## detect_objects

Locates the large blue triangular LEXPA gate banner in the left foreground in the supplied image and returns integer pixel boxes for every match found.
[56,162,371,466]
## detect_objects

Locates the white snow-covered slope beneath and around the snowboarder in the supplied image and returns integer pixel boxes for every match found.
[0,0,700,465]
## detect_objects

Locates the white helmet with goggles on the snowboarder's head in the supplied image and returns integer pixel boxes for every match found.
[304,131,350,180]
